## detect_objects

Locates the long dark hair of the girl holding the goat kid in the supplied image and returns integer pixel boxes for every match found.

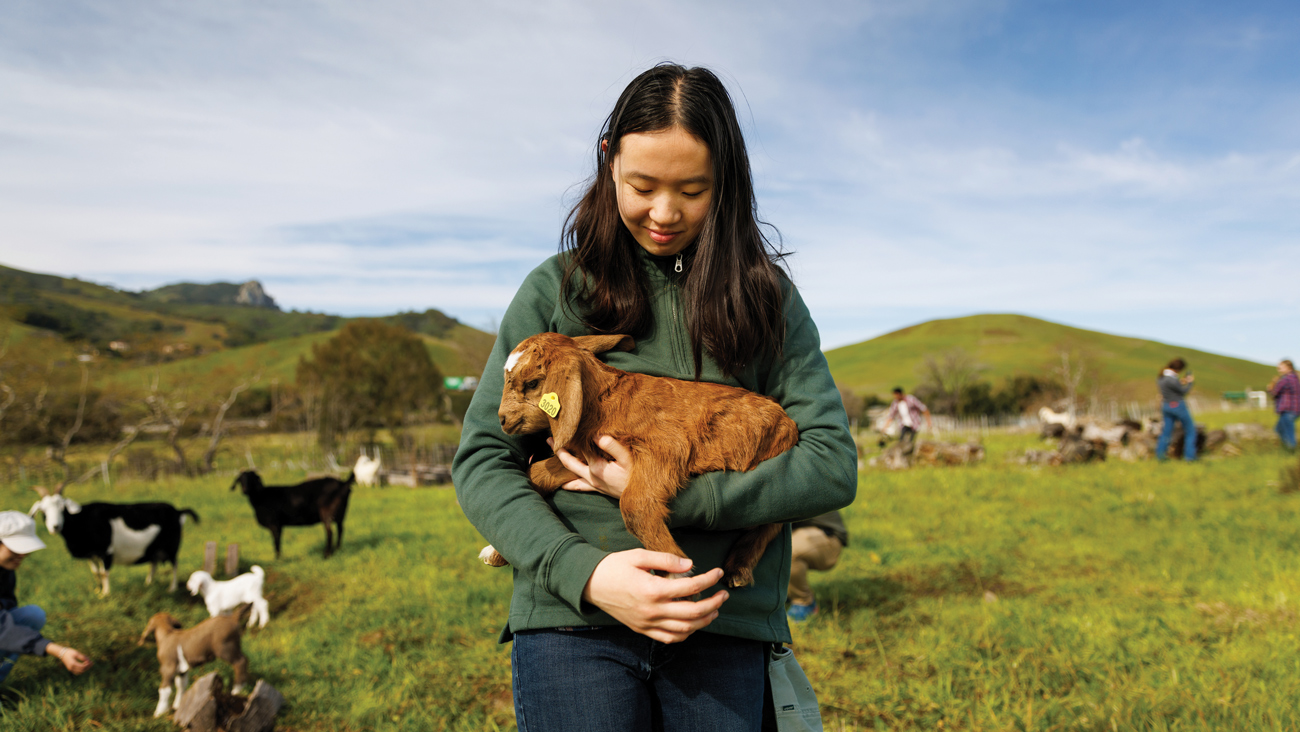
[560,64,787,380]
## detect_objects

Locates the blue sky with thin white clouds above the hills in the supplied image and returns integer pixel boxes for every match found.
[0,0,1300,361]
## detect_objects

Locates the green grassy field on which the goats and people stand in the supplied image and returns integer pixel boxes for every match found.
[0,412,1300,731]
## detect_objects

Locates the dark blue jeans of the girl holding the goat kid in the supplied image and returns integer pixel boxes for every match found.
[511,625,771,732]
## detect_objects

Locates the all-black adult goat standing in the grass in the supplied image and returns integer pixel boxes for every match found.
[230,471,356,559]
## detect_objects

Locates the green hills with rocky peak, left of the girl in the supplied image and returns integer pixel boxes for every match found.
[0,260,494,386]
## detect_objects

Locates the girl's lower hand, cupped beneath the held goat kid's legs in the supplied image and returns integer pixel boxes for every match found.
[582,549,729,644]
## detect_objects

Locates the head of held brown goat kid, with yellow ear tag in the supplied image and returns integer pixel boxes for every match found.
[497,333,636,447]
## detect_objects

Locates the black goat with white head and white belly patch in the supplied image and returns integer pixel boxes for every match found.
[27,485,199,595]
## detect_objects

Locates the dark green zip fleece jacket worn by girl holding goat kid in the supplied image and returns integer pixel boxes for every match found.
[452,250,857,642]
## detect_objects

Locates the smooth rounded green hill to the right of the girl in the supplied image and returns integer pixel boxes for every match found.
[826,315,1275,400]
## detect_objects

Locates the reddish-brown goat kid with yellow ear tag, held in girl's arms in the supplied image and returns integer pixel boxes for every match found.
[480,333,800,588]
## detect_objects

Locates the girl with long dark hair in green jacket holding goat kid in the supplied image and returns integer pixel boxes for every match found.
[454,64,857,731]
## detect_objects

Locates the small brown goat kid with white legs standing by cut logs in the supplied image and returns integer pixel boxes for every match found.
[137,612,248,716]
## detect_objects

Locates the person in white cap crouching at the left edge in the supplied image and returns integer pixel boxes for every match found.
[0,511,91,684]
